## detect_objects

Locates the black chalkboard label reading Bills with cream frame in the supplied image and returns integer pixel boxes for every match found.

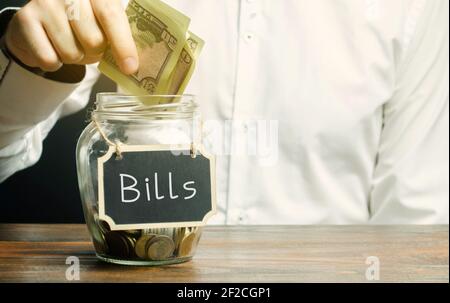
[98,145,216,230]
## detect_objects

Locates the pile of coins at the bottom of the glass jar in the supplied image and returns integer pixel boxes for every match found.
[90,215,201,261]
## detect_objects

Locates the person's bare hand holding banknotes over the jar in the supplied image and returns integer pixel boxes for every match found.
[5,0,139,74]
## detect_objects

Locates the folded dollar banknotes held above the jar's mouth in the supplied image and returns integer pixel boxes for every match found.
[98,0,204,102]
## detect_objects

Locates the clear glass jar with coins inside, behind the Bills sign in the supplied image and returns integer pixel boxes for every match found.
[76,93,202,265]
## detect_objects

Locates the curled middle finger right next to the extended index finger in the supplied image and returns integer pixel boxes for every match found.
[69,0,107,57]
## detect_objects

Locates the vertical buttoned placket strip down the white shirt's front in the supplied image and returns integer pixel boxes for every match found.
[226,0,262,224]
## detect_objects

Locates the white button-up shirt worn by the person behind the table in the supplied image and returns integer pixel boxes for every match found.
[0,0,449,224]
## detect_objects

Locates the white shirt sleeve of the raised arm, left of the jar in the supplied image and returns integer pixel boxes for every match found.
[0,61,98,182]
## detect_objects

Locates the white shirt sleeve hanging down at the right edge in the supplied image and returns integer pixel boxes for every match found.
[369,0,449,224]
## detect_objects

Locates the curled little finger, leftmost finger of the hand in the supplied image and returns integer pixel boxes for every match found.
[5,8,62,71]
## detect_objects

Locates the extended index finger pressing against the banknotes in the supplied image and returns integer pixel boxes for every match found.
[91,0,139,74]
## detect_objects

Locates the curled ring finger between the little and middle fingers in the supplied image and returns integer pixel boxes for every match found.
[41,1,84,64]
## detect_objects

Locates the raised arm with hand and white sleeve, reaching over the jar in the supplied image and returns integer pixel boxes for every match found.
[0,0,138,182]
